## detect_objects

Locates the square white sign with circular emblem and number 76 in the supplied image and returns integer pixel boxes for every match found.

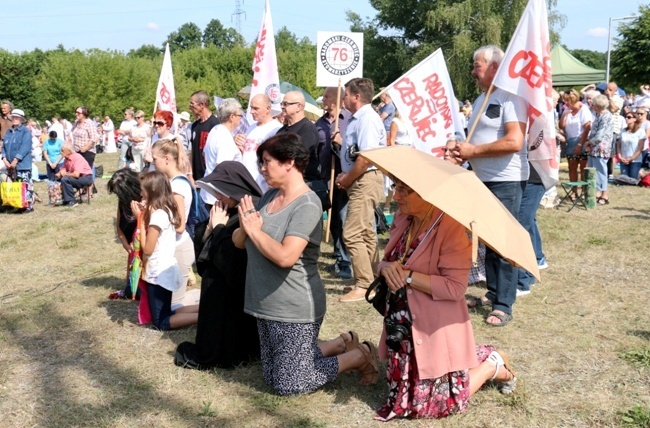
[316,31,363,87]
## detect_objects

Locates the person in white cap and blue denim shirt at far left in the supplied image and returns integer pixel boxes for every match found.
[2,109,34,213]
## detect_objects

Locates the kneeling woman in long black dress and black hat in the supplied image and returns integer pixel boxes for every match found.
[174,161,262,370]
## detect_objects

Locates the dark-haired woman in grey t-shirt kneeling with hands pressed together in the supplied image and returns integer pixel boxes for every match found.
[233,133,379,395]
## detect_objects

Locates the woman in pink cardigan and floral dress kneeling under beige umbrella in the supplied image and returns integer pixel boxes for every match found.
[375,177,517,421]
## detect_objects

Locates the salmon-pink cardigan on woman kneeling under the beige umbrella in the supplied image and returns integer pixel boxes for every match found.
[378,208,478,379]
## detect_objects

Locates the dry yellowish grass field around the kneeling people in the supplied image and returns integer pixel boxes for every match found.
[0,154,650,428]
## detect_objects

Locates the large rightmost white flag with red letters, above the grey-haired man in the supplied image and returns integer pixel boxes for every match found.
[492,0,559,189]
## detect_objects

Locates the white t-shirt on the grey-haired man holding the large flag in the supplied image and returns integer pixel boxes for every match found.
[468,88,529,182]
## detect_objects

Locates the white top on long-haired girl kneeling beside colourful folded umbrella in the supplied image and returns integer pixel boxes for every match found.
[144,209,183,292]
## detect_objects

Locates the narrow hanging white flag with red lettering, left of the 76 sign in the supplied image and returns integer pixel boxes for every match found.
[246,0,281,123]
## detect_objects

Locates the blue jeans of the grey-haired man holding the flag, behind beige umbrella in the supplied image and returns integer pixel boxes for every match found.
[483,181,526,314]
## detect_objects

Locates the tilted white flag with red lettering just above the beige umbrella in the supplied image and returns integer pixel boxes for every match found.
[386,49,465,158]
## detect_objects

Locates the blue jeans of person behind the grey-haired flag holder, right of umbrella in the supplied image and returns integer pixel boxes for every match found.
[517,182,546,291]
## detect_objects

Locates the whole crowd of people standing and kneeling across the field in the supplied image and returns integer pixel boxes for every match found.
[0,46,650,421]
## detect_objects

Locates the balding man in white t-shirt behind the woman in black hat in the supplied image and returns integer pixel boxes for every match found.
[235,94,282,192]
